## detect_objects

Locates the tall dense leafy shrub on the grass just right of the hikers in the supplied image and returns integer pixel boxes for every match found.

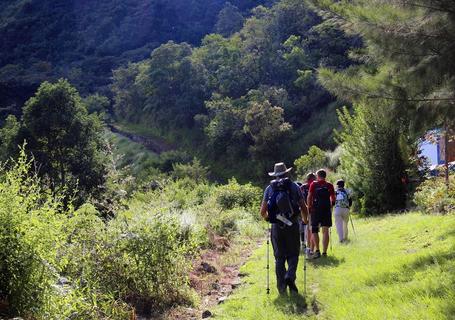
[337,104,406,215]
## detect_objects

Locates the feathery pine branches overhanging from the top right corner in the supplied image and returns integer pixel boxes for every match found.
[315,0,455,155]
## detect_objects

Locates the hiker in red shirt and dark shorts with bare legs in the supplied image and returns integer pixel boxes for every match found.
[307,169,335,259]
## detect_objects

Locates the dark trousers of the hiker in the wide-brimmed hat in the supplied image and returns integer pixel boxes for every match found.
[272,223,300,291]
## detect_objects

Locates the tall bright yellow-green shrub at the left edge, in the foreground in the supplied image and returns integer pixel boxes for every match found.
[0,150,65,316]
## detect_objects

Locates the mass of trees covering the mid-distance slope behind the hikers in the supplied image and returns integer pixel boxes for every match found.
[112,0,359,179]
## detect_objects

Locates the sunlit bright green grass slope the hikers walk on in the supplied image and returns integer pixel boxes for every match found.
[215,213,455,320]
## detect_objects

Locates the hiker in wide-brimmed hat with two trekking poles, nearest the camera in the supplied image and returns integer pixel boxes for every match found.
[261,162,308,294]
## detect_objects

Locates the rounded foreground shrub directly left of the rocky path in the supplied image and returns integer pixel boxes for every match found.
[93,211,198,311]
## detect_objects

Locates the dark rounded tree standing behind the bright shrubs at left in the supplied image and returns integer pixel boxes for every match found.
[21,80,105,198]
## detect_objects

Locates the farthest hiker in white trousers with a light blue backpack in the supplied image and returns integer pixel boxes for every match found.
[334,180,352,243]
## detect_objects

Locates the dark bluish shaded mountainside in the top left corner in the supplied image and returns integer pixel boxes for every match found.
[0,0,271,113]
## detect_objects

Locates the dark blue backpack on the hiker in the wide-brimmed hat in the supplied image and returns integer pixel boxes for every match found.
[267,178,299,225]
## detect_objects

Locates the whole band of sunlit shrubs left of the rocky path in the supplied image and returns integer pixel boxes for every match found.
[0,151,246,319]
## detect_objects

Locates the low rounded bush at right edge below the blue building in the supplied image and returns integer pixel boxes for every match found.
[414,175,455,213]
